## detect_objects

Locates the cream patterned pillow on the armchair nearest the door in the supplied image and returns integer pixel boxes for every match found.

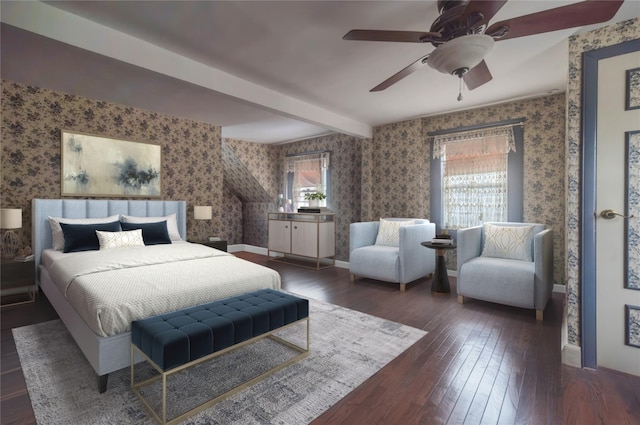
[482,223,533,261]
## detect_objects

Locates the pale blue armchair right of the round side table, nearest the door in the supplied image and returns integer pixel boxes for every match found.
[457,223,553,320]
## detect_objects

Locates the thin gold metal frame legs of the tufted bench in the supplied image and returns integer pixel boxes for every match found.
[131,317,309,425]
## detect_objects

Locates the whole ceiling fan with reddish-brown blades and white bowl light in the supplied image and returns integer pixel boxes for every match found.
[342,0,624,100]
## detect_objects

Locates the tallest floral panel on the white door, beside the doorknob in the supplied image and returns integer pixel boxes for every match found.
[624,130,640,291]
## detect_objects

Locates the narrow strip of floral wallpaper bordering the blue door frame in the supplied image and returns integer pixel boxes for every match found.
[565,18,640,346]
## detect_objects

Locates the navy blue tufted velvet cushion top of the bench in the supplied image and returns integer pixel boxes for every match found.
[131,289,309,371]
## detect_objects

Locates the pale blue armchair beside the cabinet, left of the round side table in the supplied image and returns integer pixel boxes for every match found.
[349,218,436,292]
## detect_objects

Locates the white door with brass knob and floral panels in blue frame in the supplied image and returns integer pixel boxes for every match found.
[595,52,640,376]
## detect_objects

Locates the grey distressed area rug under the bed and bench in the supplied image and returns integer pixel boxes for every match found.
[13,300,426,425]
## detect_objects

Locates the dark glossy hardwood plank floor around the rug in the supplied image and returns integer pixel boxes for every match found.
[0,252,640,425]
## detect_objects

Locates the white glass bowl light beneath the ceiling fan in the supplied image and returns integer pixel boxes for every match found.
[427,34,493,77]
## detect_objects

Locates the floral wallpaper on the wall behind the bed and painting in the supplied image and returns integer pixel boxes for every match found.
[0,80,222,246]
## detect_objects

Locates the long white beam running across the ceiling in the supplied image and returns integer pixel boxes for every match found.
[0,1,373,138]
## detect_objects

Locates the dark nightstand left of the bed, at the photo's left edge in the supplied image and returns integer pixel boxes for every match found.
[0,258,36,307]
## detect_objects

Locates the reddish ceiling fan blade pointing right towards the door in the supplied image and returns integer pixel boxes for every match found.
[485,0,624,40]
